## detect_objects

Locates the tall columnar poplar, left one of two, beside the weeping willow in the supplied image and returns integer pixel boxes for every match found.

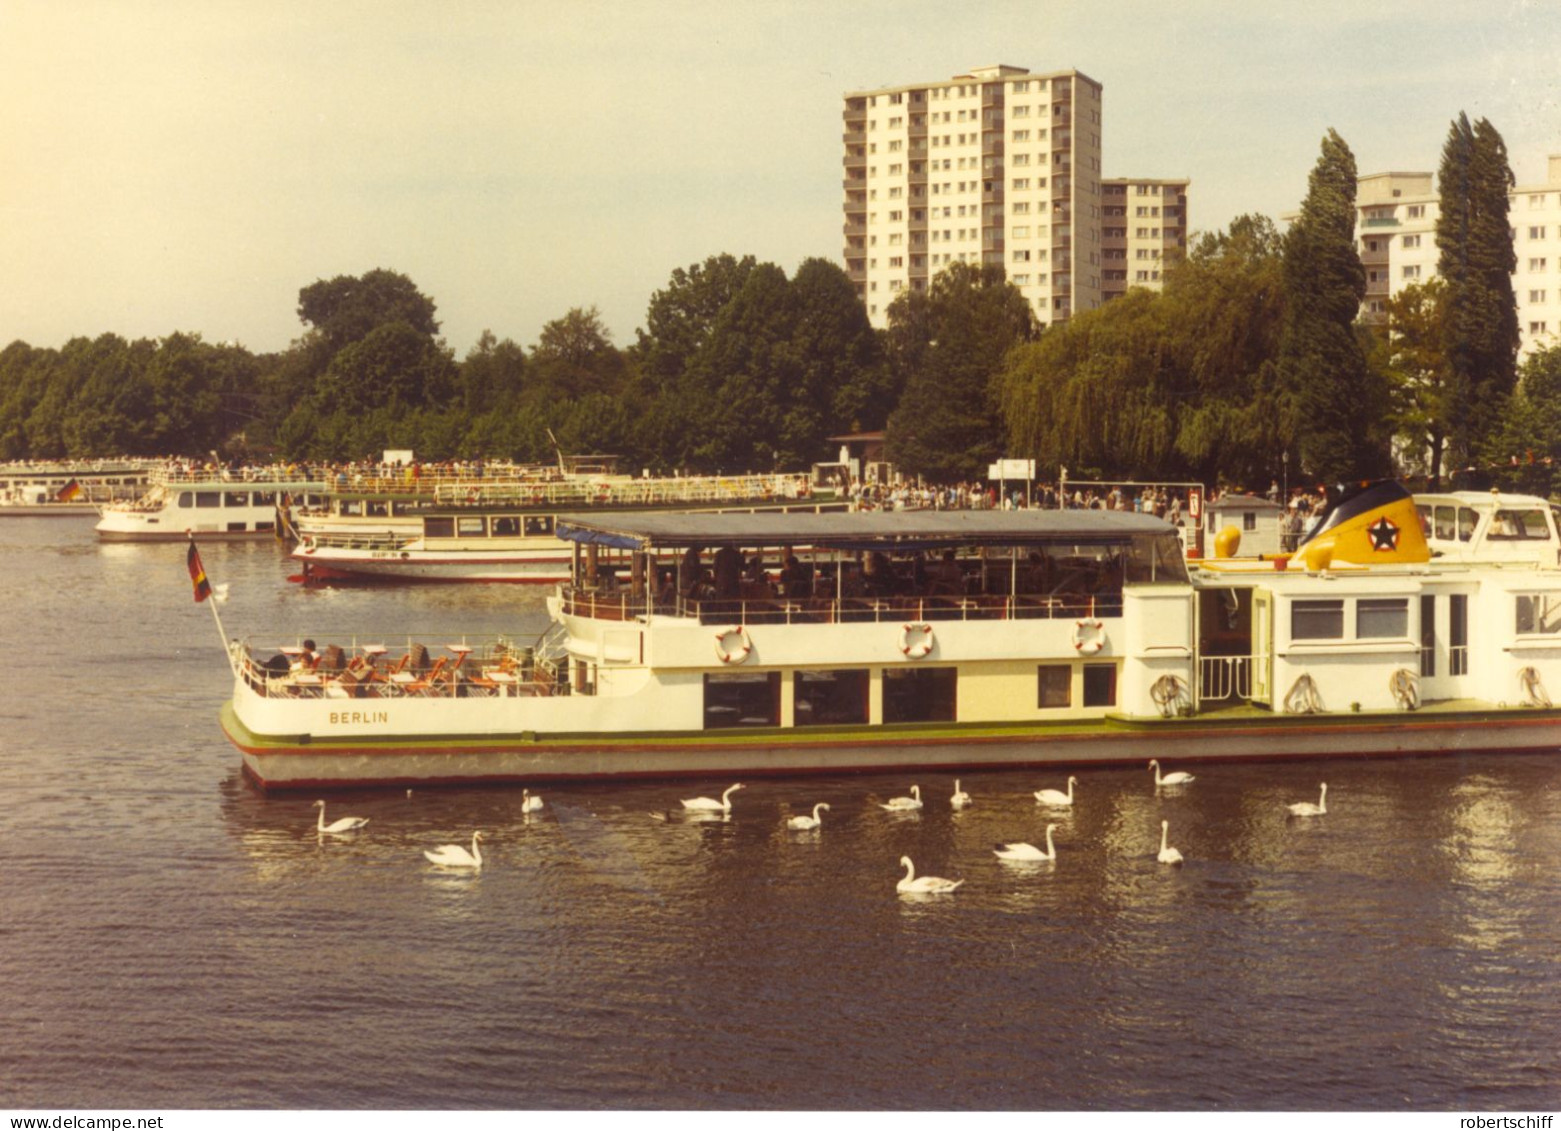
[1278,129,1386,482]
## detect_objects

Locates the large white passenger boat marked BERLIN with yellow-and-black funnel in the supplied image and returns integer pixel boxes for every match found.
[222,484,1561,789]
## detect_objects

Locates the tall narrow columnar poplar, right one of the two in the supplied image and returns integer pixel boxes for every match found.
[1436,114,1519,477]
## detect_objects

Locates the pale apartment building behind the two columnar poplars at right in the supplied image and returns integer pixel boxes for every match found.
[1355,156,1561,359]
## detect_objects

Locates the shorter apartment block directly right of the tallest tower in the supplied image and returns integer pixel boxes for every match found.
[1101,176,1189,300]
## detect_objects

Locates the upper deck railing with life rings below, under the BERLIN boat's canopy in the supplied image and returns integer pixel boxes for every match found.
[560,587,1122,624]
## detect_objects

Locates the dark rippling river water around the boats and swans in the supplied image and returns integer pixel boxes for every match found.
[0,518,1561,1111]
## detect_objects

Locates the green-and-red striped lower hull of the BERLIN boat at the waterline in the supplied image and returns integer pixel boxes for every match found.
[222,702,1561,791]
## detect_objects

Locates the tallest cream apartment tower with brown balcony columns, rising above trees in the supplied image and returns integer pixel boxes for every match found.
[843,64,1102,326]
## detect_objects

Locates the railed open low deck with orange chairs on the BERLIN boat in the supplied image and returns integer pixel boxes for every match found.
[233,636,570,699]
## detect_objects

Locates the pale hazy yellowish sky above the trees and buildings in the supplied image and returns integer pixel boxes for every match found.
[0,0,1561,357]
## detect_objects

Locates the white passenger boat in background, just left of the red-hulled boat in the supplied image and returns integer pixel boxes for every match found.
[97,468,325,541]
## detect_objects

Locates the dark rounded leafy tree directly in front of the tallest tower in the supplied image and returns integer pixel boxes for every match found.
[887,264,1037,482]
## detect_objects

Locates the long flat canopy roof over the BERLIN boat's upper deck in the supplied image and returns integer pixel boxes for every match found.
[556,510,1175,549]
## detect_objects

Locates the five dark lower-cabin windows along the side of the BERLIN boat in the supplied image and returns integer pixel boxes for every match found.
[704,663,1116,730]
